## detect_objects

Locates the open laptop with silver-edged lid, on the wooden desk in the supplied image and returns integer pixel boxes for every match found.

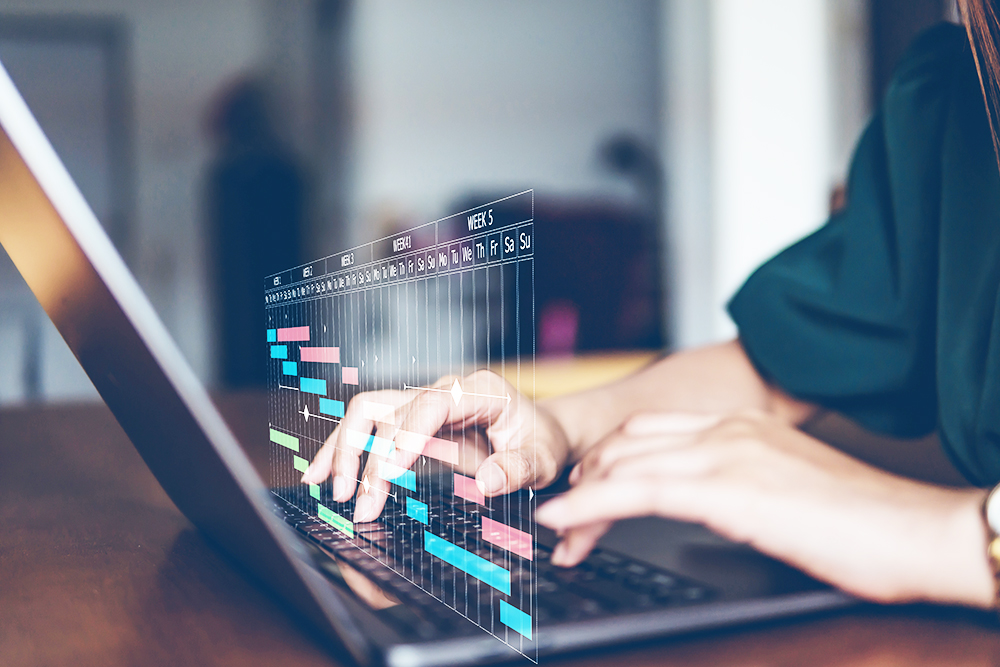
[0,60,854,667]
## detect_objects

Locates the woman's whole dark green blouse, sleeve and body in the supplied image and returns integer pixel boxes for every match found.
[729,25,1000,486]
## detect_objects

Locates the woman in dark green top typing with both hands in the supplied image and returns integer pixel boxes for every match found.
[304,0,1000,608]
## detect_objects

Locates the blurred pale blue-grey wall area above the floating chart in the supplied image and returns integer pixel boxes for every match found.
[350,0,659,241]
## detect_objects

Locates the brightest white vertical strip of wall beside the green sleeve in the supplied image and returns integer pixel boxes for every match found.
[711,0,832,336]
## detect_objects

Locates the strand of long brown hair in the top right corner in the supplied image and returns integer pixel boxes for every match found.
[958,0,1000,169]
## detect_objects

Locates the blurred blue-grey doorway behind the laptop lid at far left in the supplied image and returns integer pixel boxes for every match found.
[0,15,134,403]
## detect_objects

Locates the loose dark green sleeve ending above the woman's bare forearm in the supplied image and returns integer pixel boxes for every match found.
[729,25,967,437]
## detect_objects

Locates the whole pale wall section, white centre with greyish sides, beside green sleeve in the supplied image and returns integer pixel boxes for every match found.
[661,0,869,347]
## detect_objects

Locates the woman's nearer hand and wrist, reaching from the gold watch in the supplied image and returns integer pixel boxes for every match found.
[536,411,993,607]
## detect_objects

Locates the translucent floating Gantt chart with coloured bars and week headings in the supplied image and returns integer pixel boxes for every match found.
[261,191,537,658]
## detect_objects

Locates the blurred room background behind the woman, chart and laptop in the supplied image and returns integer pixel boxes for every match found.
[0,0,956,403]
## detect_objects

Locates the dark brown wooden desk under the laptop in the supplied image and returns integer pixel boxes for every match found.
[0,396,1000,667]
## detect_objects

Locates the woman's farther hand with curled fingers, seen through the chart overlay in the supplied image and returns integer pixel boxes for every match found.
[302,370,569,523]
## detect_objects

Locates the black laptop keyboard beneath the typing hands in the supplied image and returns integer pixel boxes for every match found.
[275,500,714,634]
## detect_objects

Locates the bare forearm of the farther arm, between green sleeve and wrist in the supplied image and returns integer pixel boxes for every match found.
[543,340,816,459]
